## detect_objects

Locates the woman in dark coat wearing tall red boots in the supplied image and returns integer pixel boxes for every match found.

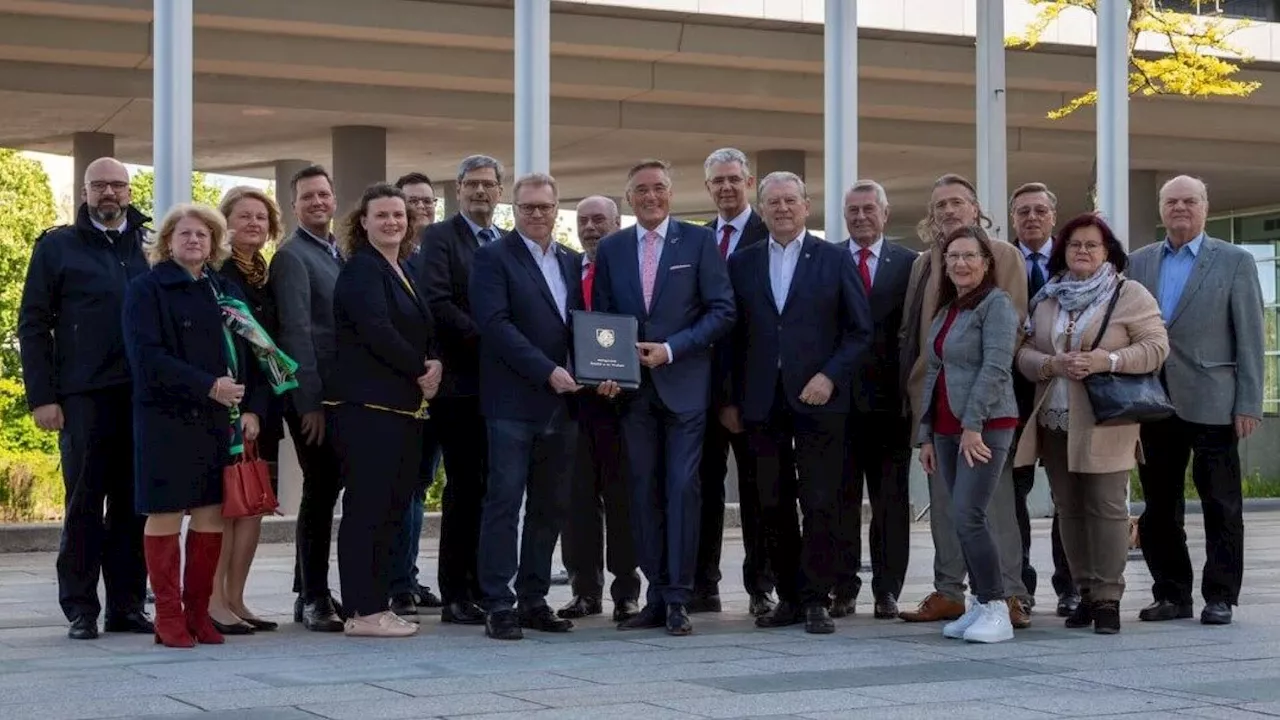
[124,199,266,647]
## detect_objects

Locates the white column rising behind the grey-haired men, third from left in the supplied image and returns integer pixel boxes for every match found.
[823,0,858,242]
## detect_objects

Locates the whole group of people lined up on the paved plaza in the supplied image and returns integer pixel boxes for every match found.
[19,149,1262,647]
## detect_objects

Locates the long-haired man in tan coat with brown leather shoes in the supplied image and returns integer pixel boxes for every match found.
[899,174,1030,628]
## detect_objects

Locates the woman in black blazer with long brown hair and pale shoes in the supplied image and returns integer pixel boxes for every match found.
[325,183,443,637]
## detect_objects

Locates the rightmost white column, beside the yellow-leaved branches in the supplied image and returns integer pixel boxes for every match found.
[1097,0,1132,249]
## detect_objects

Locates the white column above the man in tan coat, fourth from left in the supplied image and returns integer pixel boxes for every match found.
[975,0,1009,238]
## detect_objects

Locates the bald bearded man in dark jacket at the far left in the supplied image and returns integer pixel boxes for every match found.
[18,158,155,639]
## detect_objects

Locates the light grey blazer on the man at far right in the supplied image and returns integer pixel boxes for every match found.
[1125,236,1263,425]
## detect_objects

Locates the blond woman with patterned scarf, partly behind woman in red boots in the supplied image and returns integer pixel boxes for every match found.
[209,186,288,627]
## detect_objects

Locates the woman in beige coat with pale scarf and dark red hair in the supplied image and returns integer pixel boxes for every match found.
[1014,214,1169,634]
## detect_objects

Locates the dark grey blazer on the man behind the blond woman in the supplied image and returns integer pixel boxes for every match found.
[270,228,342,414]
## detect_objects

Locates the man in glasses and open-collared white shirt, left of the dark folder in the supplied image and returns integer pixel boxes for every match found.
[470,173,599,641]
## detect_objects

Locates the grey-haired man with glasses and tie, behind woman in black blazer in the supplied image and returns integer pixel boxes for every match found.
[416,155,503,625]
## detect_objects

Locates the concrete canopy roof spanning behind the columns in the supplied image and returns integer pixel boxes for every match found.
[0,0,1280,237]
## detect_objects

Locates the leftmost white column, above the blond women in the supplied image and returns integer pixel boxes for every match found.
[151,0,195,222]
